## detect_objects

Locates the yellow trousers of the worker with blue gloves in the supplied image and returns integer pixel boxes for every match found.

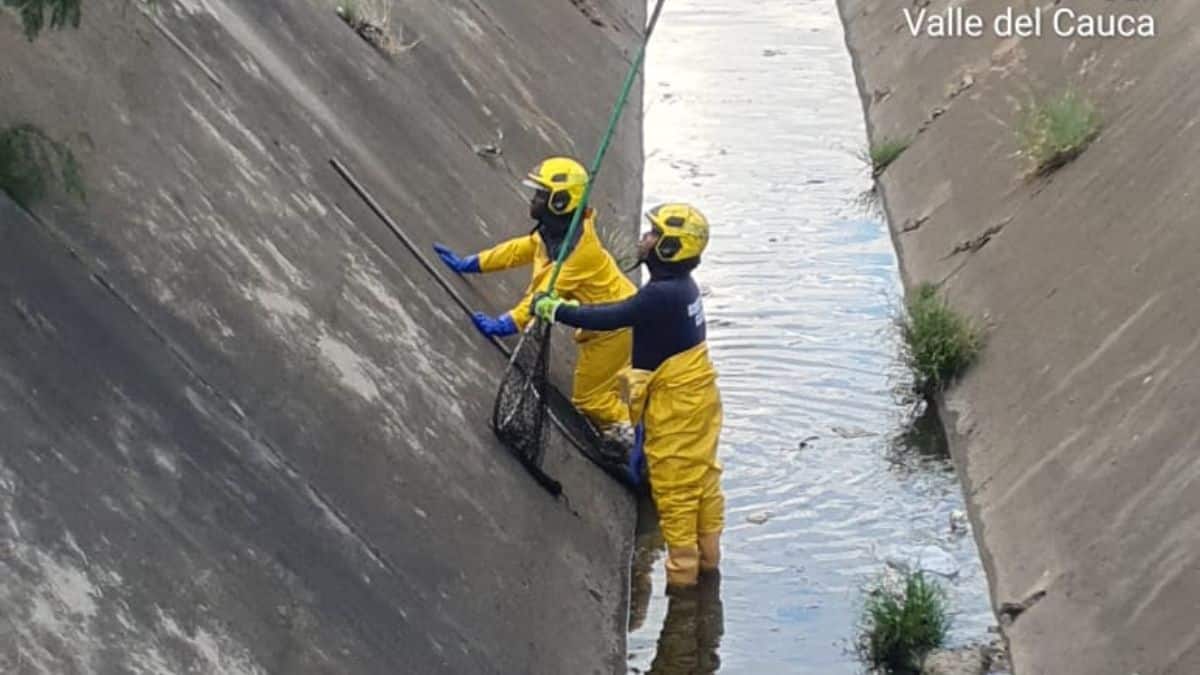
[571,328,634,428]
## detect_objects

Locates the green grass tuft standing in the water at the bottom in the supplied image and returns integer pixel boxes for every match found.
[858,572,950,675]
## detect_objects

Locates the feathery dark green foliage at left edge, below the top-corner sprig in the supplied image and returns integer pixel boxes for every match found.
[0,124,86,209]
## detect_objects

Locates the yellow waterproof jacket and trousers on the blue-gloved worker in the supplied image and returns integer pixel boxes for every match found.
[479,209,637,426]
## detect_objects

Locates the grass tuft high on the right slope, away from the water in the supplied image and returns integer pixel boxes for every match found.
[1016,89,1102,175]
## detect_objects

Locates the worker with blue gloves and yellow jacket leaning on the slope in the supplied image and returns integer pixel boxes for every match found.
[433,157,637,449]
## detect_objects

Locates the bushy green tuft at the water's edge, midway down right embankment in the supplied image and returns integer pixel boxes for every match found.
[900,283,983,396]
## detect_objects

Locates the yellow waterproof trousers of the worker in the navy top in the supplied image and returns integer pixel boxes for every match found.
[625,342,725,557]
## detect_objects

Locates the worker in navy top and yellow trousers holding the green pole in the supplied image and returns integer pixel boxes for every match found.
[534,204,725,586]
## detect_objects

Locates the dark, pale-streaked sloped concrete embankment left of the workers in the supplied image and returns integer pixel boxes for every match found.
[0,0,644,675]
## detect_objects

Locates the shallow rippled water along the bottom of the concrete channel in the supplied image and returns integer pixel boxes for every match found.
[629,0,992,675]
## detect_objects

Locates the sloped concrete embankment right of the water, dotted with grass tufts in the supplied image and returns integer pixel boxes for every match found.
[840,0,1200,675]
